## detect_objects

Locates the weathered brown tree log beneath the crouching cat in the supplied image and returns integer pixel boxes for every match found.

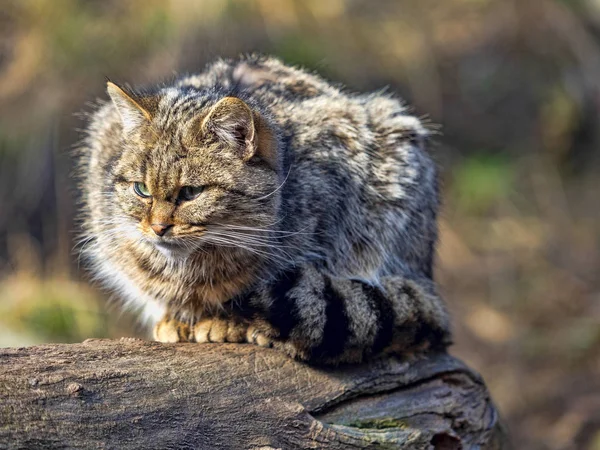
[0,339,505,450]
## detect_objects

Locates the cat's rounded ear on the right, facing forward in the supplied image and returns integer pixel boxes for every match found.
[201,97,257,161]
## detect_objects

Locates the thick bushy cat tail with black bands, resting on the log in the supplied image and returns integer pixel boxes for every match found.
[239,266,450,364]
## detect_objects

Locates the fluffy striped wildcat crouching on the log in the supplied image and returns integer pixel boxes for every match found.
[78,56,451,364]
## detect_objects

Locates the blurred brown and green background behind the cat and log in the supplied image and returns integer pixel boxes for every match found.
[0,0,600,450]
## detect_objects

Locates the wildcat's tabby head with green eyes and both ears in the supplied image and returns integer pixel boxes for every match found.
[102,82,283,255]
